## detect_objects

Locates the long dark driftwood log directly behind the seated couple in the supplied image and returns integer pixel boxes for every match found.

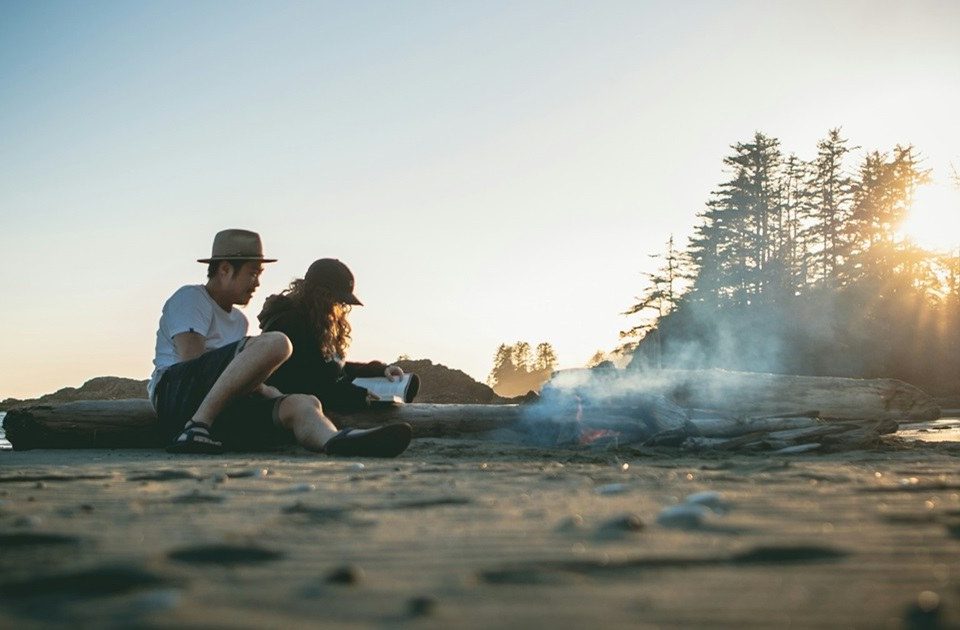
[3,399,520,450]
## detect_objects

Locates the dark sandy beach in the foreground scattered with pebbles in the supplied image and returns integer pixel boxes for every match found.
[0,440,960,628]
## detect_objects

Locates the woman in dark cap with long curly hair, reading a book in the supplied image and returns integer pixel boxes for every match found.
[258,258,403,412]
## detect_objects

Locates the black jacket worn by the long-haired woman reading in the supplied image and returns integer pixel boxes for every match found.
[258,295,387,411]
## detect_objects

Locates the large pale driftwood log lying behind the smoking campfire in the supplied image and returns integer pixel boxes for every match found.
[546,370,940,421]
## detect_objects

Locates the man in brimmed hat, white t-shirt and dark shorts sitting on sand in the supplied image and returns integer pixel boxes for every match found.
[147,229,411,457]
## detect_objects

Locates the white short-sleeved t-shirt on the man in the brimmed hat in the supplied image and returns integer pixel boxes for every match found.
[147,284,248,400]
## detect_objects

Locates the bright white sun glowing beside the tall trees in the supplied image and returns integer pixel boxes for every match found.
[900,182,960,252]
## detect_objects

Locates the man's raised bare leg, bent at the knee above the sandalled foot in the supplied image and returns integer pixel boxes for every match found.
[191,332,293,426]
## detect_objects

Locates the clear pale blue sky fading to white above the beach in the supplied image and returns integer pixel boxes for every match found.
[0,0,960,398]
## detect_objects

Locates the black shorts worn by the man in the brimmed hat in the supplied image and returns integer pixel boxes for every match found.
[154,338,293,450]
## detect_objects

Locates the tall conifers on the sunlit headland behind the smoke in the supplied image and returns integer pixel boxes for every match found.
[620,129,960,394]
